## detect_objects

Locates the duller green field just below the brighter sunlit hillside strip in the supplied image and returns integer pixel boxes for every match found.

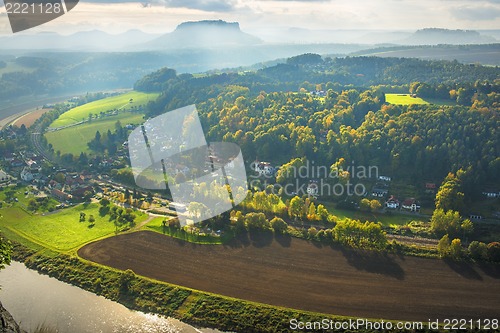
[45,112,144,155]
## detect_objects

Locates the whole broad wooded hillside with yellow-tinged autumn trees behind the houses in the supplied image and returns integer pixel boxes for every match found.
[136,55,500,198]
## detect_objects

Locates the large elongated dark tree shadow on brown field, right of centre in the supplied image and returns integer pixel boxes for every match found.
[337,247,405,280]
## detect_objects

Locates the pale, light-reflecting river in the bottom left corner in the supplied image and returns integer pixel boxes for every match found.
[0,262,218,333]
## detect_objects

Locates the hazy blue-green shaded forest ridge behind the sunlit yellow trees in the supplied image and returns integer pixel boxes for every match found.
[135,54,500,91]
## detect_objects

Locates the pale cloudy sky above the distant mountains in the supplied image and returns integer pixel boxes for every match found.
[0,0,500,34]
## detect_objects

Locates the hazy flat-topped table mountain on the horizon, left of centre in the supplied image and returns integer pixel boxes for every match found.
[145,20,262,49]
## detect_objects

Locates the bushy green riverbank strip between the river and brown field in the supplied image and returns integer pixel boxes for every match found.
[4,239,368,332]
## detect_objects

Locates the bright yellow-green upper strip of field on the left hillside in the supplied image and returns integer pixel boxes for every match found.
[50,91,158,128]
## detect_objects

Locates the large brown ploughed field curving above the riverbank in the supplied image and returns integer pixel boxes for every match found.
[78,231,500,321]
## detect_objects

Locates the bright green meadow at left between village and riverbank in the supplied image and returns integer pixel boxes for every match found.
[0,198,147,251]
